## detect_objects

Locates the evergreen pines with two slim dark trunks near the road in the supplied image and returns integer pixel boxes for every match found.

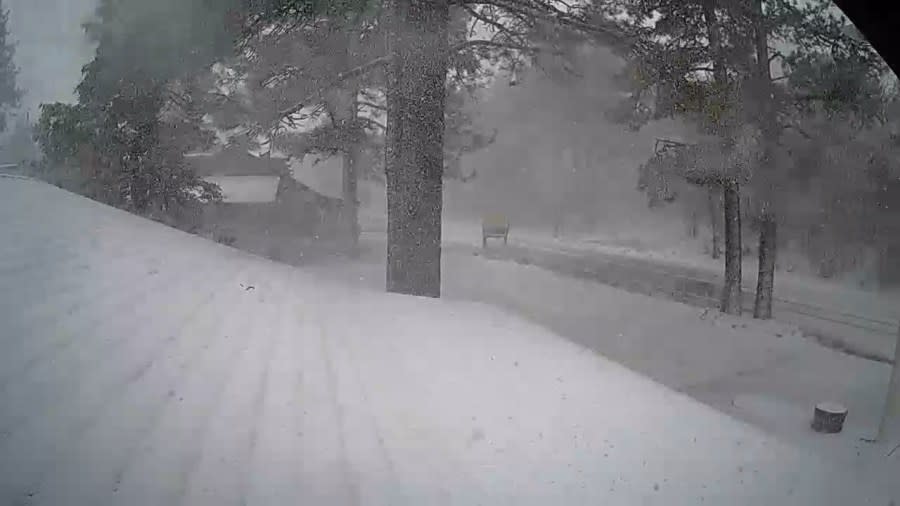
[616,0,882,318]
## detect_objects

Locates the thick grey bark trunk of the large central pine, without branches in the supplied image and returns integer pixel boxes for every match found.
[385,0,450,297]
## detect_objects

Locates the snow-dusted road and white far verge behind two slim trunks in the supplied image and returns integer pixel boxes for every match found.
[428,217,900,361]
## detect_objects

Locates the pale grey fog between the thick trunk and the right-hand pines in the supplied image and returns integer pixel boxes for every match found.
[447,49,691,251]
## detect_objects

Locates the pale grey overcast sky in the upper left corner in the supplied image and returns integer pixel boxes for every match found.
[3,0,96,115]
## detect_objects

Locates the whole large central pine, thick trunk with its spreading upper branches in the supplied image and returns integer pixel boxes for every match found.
[241,0,627,297]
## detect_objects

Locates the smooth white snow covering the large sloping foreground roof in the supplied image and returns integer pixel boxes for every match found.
[0,178,887,505]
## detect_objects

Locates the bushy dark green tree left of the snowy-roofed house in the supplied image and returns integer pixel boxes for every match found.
[37,0,233,215]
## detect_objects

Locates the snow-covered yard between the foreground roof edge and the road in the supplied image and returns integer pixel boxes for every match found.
[314,232,900,494]
